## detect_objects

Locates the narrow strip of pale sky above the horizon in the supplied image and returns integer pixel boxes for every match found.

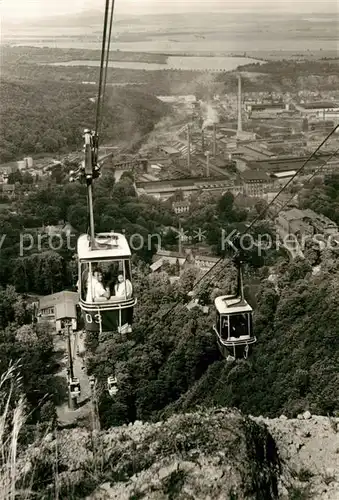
[0,0,339,20]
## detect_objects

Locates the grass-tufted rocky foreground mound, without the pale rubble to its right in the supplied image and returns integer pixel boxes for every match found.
[16,410,280,500]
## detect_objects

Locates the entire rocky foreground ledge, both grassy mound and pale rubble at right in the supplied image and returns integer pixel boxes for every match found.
[14,409,339,500]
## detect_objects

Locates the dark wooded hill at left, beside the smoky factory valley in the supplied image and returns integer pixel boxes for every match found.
[0,78,167,162]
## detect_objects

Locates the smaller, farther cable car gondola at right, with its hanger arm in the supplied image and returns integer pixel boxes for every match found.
[213,256,257,359]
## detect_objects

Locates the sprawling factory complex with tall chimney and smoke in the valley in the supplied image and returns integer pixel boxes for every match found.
[105,76,339,204]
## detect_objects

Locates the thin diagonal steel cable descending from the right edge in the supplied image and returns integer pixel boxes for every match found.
[151,123,339,330]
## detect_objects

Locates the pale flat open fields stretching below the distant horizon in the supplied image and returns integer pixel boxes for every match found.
[2,11,339,58]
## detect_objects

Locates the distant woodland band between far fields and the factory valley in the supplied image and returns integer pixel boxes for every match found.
[2,47,339,105]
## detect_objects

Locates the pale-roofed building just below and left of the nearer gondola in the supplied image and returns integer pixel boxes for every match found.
[38,291,79,332]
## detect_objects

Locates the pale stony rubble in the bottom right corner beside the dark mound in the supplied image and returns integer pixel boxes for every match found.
[253,411,339,500]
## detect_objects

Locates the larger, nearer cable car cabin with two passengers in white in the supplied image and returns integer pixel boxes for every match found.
[78,233,136,333]
